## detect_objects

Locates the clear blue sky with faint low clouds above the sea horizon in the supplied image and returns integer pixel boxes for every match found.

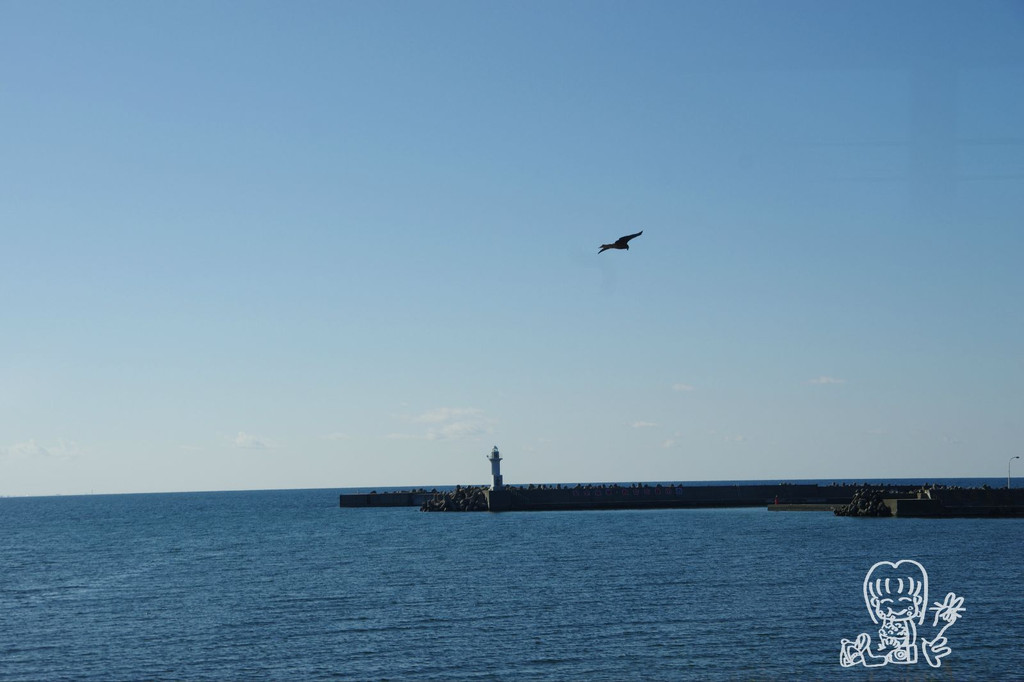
[0,0,1024,496]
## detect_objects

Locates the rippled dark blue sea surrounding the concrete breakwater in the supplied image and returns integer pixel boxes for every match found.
[0,479,1024,682]
